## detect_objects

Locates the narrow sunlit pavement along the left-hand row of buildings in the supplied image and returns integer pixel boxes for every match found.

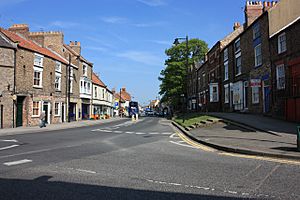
[0,117,128,136]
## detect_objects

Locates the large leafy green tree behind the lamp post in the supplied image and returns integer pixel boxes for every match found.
[158,39,208,108]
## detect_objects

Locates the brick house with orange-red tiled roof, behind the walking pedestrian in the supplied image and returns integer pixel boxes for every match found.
[1,25,68,126]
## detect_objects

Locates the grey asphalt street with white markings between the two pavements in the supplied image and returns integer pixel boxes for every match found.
[0,117,300,200]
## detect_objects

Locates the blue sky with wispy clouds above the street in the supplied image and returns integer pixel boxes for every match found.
[0,0,245,104]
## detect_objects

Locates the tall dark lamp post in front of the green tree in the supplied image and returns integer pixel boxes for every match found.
[173,36,190,123]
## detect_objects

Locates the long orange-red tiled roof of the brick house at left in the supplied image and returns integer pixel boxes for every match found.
[0,28,68,64]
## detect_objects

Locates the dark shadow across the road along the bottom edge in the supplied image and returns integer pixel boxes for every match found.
[0,176,255,200]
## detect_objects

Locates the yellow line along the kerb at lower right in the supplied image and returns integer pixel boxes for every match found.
[219,152,300,165]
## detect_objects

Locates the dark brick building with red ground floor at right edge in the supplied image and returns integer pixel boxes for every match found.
[269,0,300,122]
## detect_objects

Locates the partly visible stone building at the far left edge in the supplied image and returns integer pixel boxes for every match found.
[0,33,16,128]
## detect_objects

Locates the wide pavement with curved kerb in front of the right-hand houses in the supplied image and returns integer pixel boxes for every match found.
[173,113,300,160]
